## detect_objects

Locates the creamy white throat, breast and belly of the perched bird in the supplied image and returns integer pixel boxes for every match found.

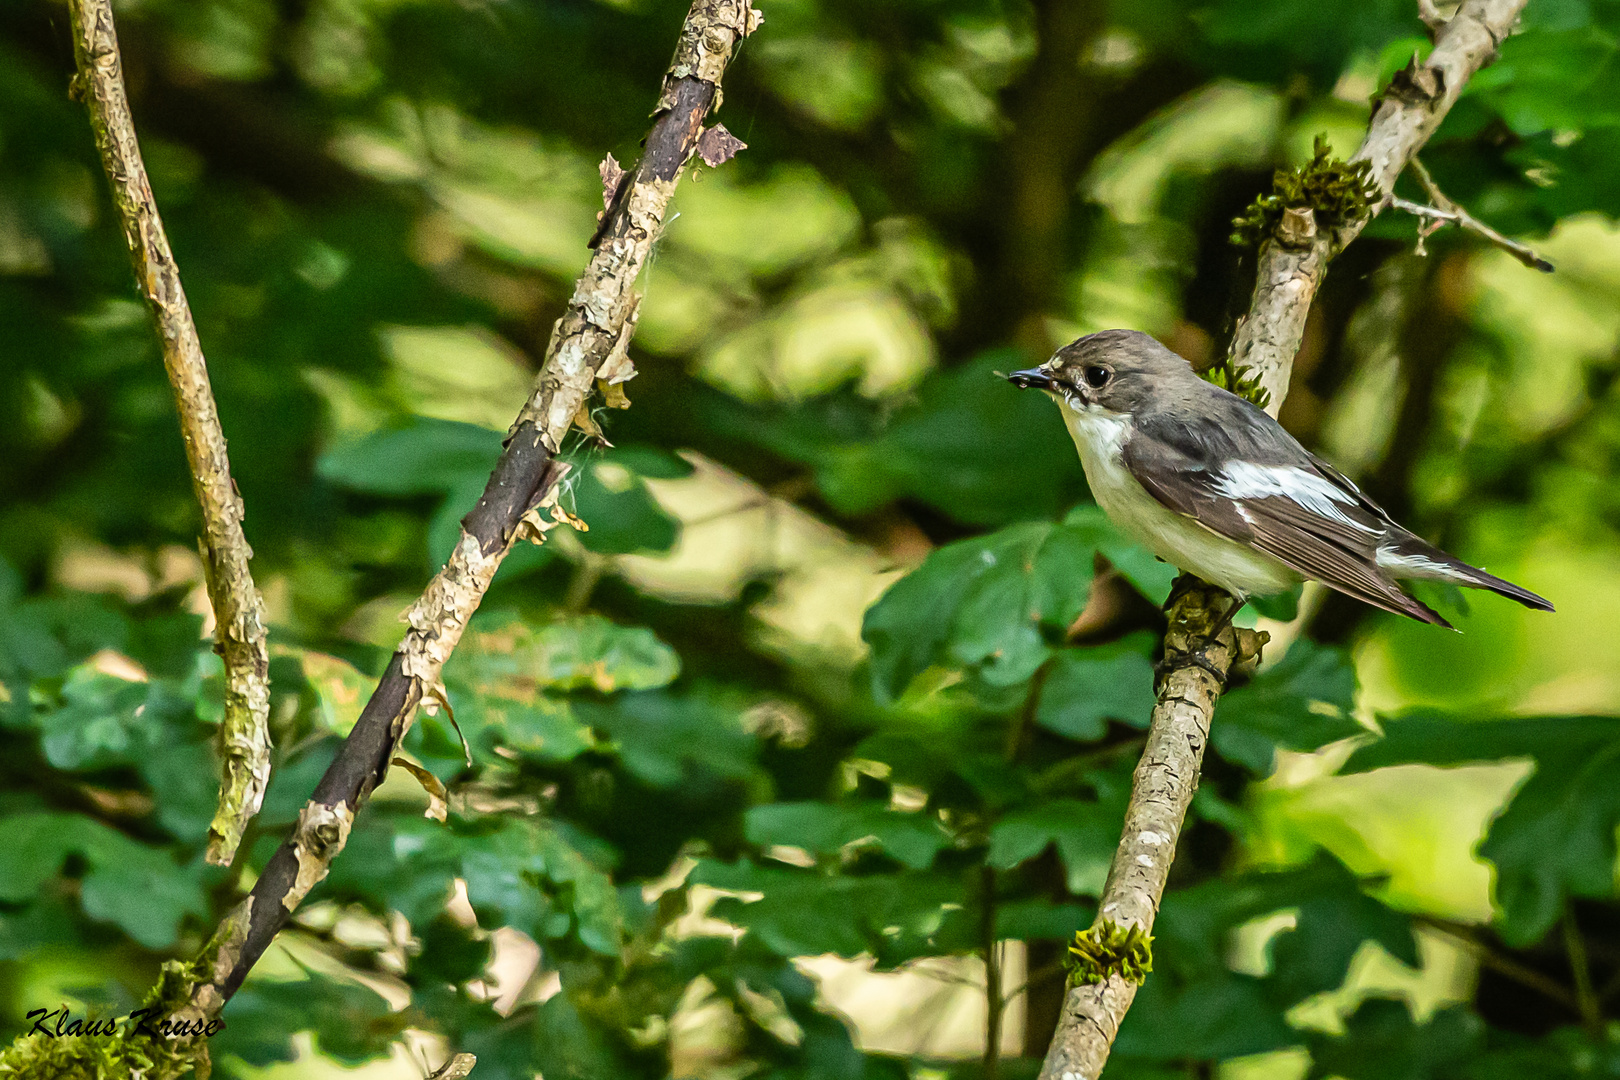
[1059,402,1299,596]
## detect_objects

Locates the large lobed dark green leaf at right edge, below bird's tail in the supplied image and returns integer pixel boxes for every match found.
[1345,712,1620,946]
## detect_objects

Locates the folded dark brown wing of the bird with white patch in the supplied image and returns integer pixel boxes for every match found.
[1123,418,1448,627]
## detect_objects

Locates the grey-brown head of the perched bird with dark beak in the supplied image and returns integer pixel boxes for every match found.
[1008,330,1199,416]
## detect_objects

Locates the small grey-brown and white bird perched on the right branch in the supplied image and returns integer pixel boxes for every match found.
[1008,330,1552,628]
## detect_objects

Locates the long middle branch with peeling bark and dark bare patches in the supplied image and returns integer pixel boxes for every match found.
[154,0,763,1020]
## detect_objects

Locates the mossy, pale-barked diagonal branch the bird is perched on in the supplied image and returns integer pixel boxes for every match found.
[1040,0,1526,1080]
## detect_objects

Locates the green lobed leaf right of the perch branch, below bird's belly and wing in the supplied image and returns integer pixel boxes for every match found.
[1210,640,1366,776]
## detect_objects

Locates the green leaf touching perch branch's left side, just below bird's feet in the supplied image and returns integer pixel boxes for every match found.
[1035,631,1153,742]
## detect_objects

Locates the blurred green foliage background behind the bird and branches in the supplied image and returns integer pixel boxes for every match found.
[0,0,1620,1080]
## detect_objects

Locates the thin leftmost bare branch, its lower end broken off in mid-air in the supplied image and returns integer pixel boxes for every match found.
[70,0,271,866]
